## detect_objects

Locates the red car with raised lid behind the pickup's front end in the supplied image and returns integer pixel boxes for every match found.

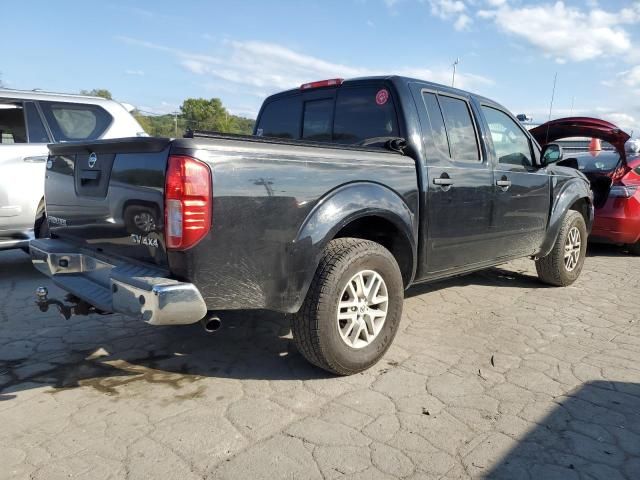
[531,117,640,255]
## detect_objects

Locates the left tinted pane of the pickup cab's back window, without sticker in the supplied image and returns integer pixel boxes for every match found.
[256,96,302,140]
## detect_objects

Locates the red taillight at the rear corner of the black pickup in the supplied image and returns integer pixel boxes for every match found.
[164,155,213,250]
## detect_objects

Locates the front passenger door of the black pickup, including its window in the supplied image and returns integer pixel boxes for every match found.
[480,104,551,257]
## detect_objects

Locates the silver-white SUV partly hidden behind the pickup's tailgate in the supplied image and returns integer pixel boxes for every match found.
[0,89,146,250]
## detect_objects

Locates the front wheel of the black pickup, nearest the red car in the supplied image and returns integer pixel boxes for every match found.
[536,210,587,287]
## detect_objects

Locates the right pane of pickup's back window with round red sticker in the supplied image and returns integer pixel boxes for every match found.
[333,87,399,144]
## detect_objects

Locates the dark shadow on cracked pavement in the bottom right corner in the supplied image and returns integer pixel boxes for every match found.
[483,381,640,480]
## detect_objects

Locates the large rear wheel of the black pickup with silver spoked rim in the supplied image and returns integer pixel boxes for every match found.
[291,238,404,375]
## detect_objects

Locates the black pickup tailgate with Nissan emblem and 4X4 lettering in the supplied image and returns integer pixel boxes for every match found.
[45,137,171,267]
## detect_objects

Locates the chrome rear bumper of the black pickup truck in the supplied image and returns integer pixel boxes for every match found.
[29,239,207,325]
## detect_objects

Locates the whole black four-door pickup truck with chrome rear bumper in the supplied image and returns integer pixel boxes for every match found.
[30,76,593,375]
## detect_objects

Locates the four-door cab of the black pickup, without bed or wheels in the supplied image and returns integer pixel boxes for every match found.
[254,76,591,281]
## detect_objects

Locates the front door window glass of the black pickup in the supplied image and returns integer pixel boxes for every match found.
[482,106,533,167]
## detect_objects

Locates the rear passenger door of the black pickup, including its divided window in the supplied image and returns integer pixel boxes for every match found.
[414,86,495,278]
